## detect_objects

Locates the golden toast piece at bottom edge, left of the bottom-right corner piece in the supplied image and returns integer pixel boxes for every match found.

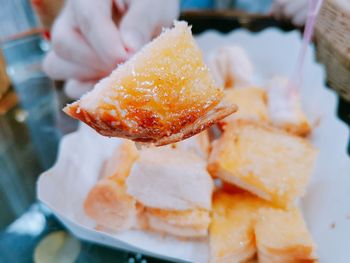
[209,191,265,263]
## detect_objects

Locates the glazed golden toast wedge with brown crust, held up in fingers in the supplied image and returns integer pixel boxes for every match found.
[64,22,236,146]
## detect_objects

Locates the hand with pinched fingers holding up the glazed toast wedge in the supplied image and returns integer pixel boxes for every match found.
[43,0,179,98]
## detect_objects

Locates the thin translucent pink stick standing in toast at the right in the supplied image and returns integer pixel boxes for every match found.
[288,0,323,95]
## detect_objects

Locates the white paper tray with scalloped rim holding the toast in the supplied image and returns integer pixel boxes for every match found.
[38,29,350,263]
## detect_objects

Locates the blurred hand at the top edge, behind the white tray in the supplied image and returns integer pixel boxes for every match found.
[272,0,308,26]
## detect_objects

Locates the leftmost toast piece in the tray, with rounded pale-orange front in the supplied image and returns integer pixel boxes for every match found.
[84,140,141,231]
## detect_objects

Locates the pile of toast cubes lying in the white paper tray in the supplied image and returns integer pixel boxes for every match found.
[84,40,317,263]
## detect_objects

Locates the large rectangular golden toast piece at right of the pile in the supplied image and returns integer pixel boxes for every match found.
[208,121,317,207]
